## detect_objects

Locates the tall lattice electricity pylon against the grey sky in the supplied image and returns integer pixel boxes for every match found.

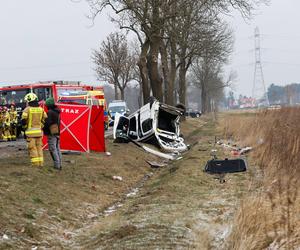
[252,27,269,106]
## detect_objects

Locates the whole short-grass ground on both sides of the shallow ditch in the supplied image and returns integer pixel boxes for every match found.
[0,117,255,249]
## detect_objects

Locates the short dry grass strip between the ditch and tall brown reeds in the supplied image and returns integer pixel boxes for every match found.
[69,117,252,250]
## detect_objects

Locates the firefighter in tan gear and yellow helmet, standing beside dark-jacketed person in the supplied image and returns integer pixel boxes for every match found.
[22,93,47,167]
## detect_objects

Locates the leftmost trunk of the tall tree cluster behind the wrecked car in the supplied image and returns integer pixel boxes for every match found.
[138,41,150,104]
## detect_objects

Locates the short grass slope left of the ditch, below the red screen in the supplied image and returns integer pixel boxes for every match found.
[0,140,156,249]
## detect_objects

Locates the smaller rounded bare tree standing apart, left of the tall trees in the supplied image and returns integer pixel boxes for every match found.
[92,32,136,100]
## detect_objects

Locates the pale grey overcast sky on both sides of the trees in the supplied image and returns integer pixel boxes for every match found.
[0,0,300,95]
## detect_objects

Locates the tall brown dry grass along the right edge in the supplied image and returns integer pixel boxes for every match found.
[221,108,300,249]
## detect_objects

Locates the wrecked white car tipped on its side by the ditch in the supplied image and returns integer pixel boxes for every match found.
[113,100,187,152]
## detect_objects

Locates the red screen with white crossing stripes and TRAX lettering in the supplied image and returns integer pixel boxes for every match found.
[43,104,105,152]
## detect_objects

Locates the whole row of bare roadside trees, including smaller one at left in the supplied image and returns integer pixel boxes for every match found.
[87,0,264,112]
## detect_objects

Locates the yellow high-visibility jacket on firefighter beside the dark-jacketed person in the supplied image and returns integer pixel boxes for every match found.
[22,106,47,137]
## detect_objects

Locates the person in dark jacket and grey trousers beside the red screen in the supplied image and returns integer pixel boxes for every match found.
[44,98,62,170]
